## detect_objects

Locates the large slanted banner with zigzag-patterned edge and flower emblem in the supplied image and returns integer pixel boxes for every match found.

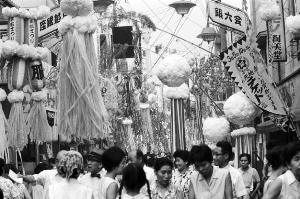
[220,36,287,115]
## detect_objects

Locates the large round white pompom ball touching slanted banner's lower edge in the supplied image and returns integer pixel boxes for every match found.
[224,91,262,125]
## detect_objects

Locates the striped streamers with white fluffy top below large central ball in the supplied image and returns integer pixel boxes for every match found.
[164,83,190,153]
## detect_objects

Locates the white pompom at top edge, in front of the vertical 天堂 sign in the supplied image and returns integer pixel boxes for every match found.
[258,0,280,21]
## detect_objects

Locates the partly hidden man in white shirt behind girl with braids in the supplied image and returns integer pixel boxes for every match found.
[128,150,156,185]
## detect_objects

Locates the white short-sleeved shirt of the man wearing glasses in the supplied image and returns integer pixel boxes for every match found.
[224,165,247,198]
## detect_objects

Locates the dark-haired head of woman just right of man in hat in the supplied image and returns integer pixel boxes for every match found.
[102,146,125,175]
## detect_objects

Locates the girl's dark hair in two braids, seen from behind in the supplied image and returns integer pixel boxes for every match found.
[119,163,151,199]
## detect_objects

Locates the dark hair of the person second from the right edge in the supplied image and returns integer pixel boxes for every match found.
[266,146,284,170]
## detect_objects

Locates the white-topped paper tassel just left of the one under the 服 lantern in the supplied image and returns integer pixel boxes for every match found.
[7,90,28,150]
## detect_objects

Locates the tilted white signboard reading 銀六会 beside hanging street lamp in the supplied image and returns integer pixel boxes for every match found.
[208,1,248,32]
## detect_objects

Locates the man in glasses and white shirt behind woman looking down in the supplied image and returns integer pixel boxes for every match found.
[213,141,247,199]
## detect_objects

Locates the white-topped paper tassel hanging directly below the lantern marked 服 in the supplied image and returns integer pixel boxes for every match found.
[26,91,52,144]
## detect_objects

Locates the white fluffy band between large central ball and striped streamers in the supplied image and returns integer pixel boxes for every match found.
[164,84,190,99]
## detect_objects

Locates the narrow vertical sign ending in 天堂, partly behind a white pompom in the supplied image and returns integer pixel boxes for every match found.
[267,0,287,62]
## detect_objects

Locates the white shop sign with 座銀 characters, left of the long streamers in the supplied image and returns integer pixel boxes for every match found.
[38,8,67,37]
